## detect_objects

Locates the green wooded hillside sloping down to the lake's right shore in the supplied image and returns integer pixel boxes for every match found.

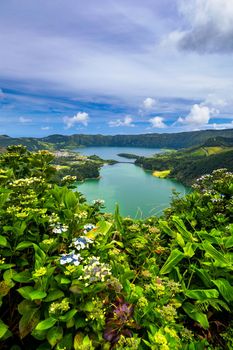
[135,141,233,185]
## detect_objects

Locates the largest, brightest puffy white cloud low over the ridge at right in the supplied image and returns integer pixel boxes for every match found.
[177,104,216,126]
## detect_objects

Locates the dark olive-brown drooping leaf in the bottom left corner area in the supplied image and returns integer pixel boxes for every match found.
[19,308,40,339]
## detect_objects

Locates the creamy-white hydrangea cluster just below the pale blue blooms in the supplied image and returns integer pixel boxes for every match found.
[79,256,111,286]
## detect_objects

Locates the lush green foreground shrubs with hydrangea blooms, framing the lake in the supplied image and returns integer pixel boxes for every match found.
[0,146,233,350]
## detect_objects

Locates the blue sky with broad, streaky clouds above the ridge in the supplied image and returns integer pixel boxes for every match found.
[0,0,233,137]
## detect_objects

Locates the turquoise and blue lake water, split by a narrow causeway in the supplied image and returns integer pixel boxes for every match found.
[76,147,190,218]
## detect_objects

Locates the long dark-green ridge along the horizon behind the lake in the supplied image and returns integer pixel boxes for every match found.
[0,129,233,150]
